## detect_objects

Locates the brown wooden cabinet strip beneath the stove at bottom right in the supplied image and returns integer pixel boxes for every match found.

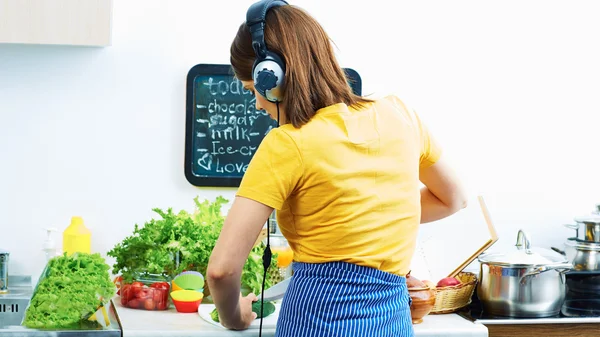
[486,323,600,337]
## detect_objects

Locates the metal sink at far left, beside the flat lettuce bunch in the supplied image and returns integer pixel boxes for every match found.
[0,275,33,326]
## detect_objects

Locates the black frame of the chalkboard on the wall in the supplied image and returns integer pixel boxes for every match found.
[184,64,362,187]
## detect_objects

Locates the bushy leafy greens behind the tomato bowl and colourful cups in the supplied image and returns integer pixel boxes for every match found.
[108,197,277,294]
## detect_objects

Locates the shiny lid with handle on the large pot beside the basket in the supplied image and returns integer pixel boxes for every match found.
[479,230,568,266]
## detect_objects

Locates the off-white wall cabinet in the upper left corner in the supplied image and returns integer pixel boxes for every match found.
[0,0,113,46]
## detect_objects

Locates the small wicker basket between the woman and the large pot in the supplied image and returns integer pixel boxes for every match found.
[430,272,477,314]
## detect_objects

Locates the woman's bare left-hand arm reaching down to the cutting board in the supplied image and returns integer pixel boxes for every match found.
[207,197,273,329]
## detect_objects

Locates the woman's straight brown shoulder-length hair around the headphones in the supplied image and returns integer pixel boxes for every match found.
[230,5,371,128]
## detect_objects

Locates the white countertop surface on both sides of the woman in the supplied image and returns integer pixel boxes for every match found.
[114,297,488,337]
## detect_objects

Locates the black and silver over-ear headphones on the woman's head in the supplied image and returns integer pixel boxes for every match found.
[246,0,288,103]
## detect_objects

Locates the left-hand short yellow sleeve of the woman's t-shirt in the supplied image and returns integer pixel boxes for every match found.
[236,128,304,210]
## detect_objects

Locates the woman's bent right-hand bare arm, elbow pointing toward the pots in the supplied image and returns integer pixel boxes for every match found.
[419,158,467,223]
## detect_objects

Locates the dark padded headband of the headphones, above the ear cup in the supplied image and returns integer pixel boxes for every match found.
[246,0,288,58]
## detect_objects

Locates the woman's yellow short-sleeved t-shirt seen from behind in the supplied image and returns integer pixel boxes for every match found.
[237,96,441,275]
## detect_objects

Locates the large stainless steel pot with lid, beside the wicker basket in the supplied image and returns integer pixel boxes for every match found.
[477,230,572,317]
